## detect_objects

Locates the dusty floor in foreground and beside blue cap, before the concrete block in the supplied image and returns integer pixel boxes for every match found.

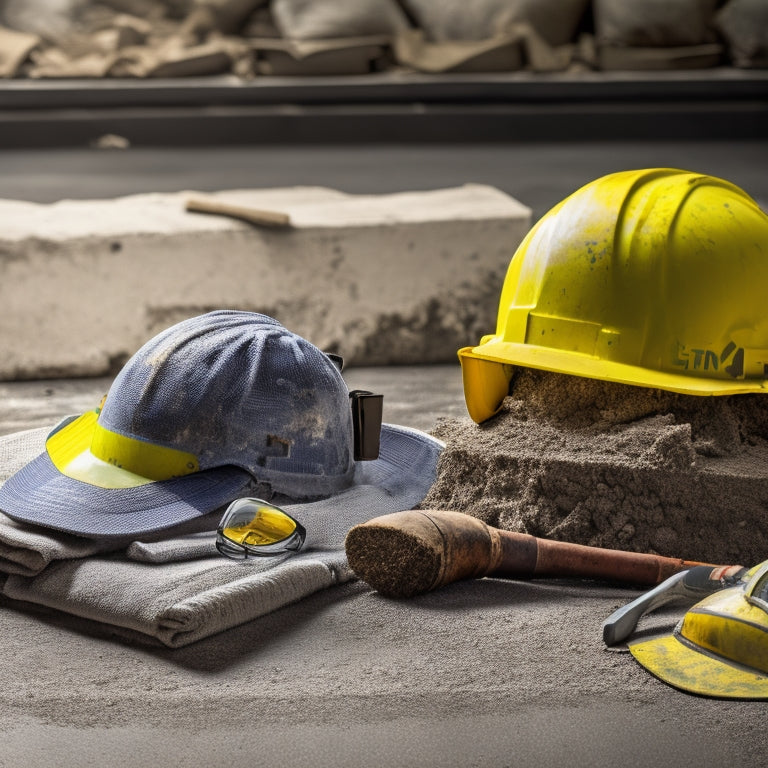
[0,366,768,768]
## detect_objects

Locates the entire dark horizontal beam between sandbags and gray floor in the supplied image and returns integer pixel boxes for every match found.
[0,69,768,148]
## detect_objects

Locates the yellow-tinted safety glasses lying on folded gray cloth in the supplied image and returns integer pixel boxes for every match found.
[216,498,307,560]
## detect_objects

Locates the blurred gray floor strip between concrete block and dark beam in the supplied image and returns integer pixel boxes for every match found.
[0,142,768,218]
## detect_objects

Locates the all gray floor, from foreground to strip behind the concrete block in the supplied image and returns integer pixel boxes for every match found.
[0,140,768,768]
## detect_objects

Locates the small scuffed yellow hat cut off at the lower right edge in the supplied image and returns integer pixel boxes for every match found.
[629,560,768,699]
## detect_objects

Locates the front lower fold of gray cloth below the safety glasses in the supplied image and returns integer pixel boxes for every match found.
[3,550,353,648]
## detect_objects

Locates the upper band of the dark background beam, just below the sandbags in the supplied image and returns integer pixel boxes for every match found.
[0,67,768,110]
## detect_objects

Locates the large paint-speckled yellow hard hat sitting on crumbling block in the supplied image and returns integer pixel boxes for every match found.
[458,168,768,422]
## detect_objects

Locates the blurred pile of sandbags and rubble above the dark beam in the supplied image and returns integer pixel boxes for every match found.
[0,0,768,79]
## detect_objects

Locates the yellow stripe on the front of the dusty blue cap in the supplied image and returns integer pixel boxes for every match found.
[45,411,199,488]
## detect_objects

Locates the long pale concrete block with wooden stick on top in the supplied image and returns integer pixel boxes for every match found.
[0,185,531,380]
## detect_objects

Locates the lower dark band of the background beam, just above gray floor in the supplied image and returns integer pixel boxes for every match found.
[0,103,768,149]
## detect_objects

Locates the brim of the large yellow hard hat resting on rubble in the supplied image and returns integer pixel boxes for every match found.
[458,339,768,423]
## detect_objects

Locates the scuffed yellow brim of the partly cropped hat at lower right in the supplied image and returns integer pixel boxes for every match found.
[629,635,768,699]
